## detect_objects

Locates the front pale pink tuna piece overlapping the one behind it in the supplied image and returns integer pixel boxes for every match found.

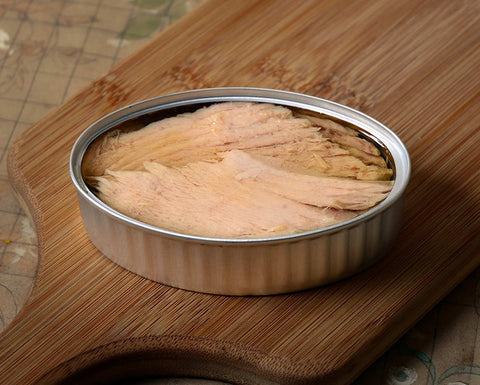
[95,150,391,238]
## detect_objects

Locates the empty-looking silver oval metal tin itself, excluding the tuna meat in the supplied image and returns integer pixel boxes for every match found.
[70,88,410,295]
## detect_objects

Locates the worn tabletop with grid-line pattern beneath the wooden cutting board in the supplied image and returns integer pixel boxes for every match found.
[0,0,480,385]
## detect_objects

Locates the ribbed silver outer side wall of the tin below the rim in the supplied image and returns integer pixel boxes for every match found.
[79,186,402,295]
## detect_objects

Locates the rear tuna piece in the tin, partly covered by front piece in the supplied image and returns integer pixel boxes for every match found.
[82,102,392,180]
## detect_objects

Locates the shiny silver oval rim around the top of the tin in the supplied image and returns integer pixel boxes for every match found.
[69,87,411,246]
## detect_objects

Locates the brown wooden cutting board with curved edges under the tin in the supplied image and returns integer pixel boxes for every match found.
[0,0,480,384]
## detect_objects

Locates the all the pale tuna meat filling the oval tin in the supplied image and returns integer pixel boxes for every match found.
[82,102,393,238]
